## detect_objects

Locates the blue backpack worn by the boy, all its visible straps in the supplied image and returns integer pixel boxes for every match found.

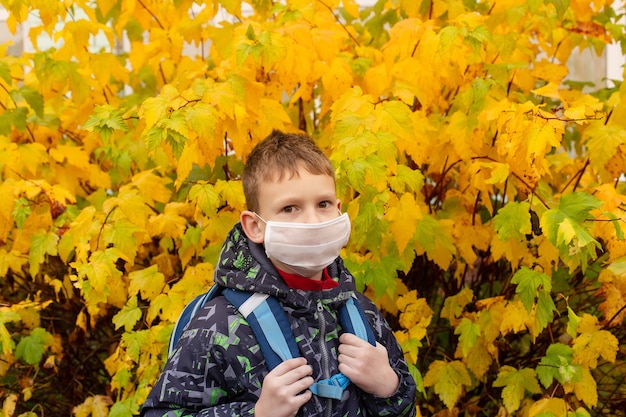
[168,285,376,400]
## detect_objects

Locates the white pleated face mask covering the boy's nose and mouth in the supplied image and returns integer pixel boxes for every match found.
[257,213,350,277]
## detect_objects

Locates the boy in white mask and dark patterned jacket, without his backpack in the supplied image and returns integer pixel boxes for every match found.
[141,130,416,417]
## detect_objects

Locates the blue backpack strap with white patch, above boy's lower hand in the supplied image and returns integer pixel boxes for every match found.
[224,289,300,370]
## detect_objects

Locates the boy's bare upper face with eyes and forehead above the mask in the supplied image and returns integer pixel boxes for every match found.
[258,168,341,228]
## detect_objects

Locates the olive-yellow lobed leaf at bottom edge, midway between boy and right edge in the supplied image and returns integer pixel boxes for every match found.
[493,365,541,413]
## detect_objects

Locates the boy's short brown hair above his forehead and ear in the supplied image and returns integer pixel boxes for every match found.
[242,130,335,211]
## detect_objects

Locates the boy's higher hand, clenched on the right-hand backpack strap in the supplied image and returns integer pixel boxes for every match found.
[339,333,400,398]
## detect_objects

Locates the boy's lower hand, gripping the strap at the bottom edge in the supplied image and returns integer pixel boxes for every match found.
[254,358,314,417]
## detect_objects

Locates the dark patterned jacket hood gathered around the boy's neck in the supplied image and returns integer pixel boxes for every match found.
[214,223,356,306]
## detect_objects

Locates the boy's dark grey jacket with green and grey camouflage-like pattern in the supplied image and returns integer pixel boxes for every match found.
[141,224,416,417]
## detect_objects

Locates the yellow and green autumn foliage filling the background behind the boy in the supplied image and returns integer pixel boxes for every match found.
[0,0,626,417]
